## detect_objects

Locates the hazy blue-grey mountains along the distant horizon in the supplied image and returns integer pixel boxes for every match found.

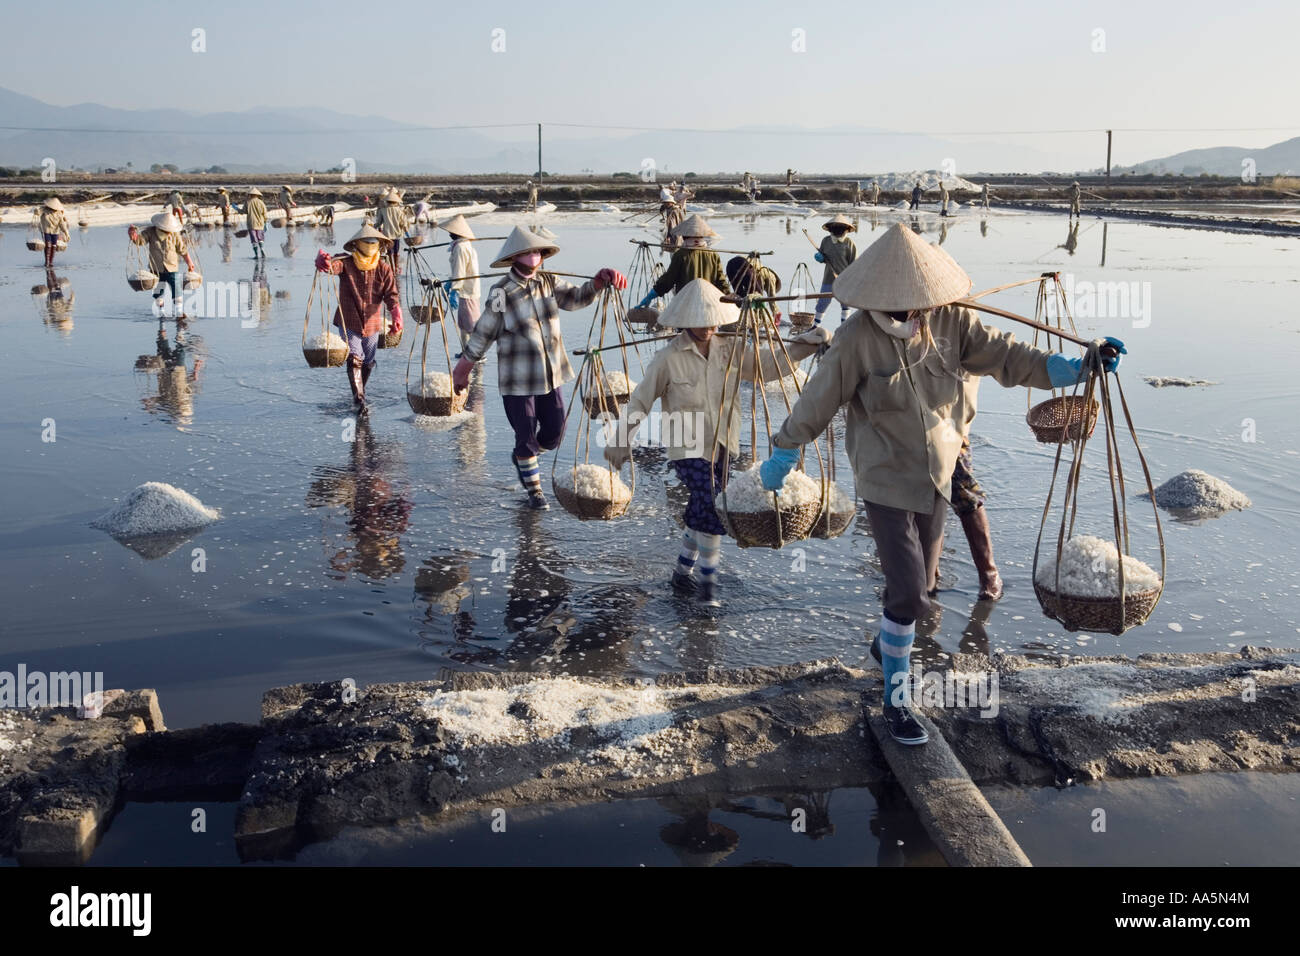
[0,87,1300,178]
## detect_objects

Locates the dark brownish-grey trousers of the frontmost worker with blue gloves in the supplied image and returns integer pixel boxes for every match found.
[865,492,948,624]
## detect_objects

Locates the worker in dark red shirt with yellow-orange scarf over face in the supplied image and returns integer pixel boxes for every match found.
[316,224,402,411]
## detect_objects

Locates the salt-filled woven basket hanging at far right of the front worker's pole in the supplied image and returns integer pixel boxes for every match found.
[1034,535,1164,633]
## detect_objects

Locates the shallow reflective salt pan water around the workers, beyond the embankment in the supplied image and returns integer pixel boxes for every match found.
[0,211,1300,726]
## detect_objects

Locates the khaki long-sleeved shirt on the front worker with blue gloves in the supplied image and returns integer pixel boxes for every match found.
[775,306,1052,514]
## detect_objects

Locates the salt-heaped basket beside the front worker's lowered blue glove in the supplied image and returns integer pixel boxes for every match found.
[714,466,822,548]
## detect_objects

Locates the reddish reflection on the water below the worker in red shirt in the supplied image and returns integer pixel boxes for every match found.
[307,415,411,581]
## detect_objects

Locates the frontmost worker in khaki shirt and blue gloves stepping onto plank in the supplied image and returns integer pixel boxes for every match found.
[761,224,1126,744]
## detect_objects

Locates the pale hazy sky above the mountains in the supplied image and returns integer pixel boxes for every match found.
[0,0,1300,164]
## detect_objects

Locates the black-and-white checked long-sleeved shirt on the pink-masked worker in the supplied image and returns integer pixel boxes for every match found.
[462,271,595,395]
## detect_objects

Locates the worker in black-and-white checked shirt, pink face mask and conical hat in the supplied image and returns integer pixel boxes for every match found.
[451,226,628,510]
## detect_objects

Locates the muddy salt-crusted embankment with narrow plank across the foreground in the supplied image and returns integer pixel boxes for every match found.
[0,648,1300,865]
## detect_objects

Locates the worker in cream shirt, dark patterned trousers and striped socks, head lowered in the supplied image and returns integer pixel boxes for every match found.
[605,278,831,606]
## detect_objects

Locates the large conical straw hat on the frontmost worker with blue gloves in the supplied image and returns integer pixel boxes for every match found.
[831,222,971,312]
